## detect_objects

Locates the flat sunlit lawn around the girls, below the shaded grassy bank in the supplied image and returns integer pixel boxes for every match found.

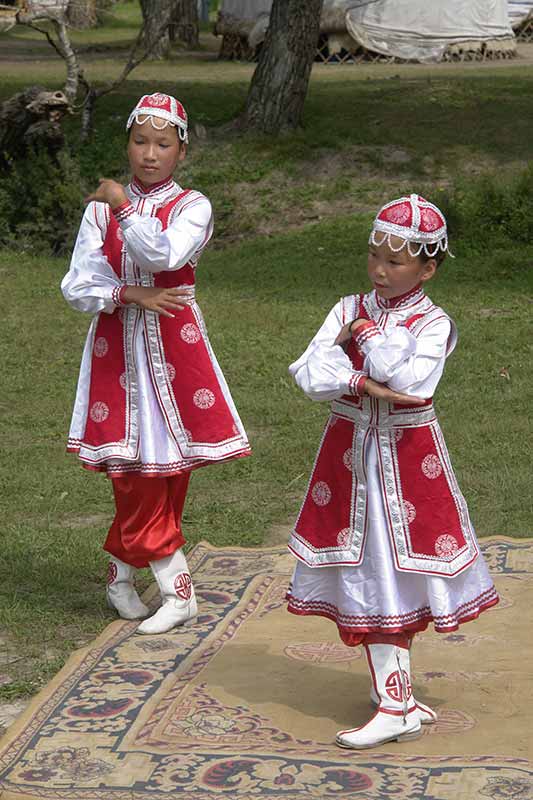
[0,218,533,697]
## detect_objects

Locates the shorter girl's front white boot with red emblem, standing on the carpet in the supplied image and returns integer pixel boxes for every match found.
[336,644,421,750]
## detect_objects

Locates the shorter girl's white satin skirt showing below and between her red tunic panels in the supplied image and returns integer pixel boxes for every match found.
[288,437,498,643]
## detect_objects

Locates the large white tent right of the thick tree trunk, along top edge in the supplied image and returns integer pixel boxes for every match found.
[346,0,515,61]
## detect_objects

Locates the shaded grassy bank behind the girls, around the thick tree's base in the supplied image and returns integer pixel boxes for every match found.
[0,61,533,247]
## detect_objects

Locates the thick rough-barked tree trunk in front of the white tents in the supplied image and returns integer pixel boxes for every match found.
[241,0,323,134]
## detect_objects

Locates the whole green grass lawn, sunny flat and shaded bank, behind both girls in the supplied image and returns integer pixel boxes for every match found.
[0,9,533,698]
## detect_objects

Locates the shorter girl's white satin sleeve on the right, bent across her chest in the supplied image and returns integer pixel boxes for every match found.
[354,315,451,398]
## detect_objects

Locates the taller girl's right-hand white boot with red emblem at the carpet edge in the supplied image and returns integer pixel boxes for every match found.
[136,549,198,634]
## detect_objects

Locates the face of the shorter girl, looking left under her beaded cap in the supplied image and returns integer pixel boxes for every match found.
[368,236,437,300]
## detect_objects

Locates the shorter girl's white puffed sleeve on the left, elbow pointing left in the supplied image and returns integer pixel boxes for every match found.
[289,302,365,401]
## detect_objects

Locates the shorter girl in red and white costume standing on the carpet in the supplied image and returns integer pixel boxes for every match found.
[288,194,498,749]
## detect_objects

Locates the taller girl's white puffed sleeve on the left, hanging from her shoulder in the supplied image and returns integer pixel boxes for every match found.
[61,203,122,314]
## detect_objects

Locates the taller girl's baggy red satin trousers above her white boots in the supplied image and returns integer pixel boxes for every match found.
[104,472,190,568]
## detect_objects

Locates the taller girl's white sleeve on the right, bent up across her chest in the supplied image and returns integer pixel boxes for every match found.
[115,192,213,273]
